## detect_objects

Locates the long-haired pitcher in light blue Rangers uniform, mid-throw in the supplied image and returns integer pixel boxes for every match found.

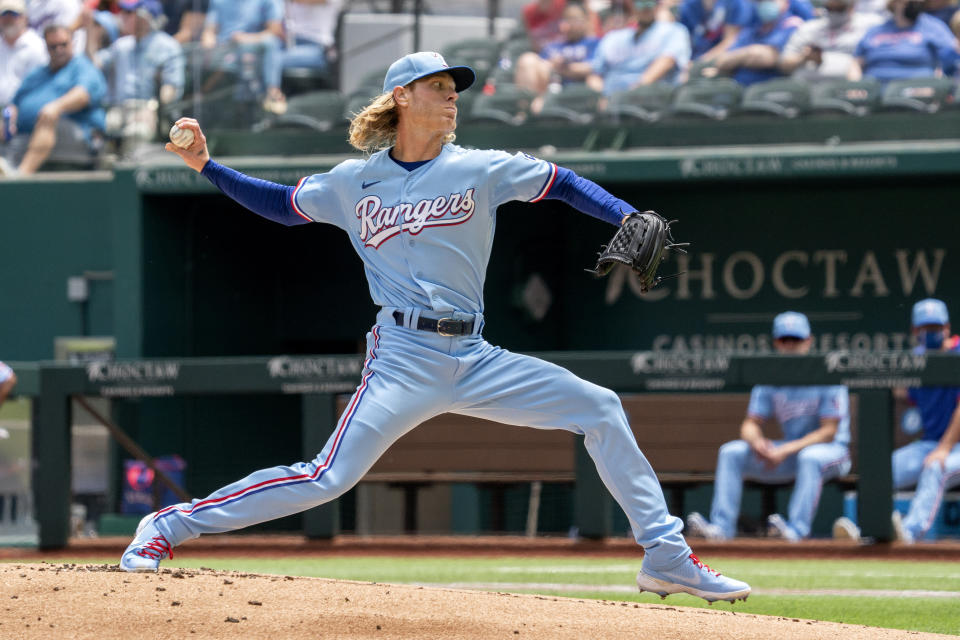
[120,51,750,602]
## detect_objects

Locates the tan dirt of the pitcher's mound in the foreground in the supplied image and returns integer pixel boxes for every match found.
[0,563,951,640]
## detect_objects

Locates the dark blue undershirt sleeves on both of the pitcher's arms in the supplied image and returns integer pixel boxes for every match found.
[201,160,635,226]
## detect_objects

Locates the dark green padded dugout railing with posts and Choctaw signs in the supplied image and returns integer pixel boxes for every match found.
[10,351,960,549]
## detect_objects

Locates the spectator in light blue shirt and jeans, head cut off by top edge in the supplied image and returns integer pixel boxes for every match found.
[201,0,287,113]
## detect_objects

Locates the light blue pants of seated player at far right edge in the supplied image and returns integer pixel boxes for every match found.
[893,440,960,540]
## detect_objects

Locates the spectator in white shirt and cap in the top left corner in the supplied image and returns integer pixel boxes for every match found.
[0,0,47,107]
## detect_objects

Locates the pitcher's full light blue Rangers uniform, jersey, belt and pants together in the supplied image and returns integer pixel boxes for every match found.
[135,144,691,570]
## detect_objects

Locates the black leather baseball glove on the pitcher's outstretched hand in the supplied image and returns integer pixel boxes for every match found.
[586,211,690,293]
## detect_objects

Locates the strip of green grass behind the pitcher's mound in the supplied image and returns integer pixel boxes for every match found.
[15,556,960,635]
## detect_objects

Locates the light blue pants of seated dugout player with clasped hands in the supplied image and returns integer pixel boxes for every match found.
[710,440,850,538]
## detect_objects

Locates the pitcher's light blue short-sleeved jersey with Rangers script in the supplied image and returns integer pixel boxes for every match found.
[293,144,557,314]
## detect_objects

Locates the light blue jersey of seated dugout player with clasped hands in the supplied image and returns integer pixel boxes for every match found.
[747,385,850,445]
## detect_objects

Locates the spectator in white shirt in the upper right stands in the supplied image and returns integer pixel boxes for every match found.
[780,0,883,81]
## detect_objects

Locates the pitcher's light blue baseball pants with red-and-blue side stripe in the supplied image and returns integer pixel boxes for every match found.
[148,308,690,570]
